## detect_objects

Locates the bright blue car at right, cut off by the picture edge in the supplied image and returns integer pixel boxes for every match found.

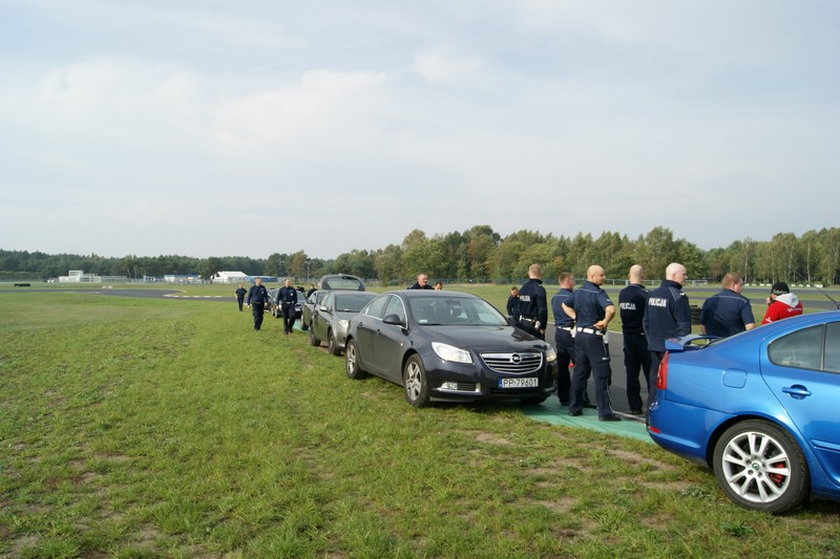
[647,311,840,513]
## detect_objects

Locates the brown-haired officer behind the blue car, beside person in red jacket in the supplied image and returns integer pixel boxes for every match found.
[700,272,755,338]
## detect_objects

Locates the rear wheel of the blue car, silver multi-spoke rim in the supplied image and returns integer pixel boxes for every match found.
[713,419,810,514]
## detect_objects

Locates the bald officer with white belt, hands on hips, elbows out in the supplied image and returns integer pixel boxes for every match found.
[561,264,621,421]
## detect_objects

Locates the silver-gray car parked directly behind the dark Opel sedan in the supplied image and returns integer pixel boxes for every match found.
[309,290,377,355]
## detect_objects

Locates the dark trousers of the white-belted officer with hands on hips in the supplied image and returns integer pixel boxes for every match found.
[569,332,612,417]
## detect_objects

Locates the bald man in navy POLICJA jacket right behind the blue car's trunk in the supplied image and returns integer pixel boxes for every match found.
[644,262,691,407]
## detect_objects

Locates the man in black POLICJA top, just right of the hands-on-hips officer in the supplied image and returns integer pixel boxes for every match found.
[618,264,651,415]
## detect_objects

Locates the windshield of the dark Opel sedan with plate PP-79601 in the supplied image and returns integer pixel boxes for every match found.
[408,297,508,326]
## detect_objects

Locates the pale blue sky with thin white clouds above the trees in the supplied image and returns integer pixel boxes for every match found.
[0,0,840,259]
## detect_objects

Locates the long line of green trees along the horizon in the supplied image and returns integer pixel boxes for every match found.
[0,225,840,285]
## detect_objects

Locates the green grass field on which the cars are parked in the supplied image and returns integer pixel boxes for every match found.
[0,286,840,559]
